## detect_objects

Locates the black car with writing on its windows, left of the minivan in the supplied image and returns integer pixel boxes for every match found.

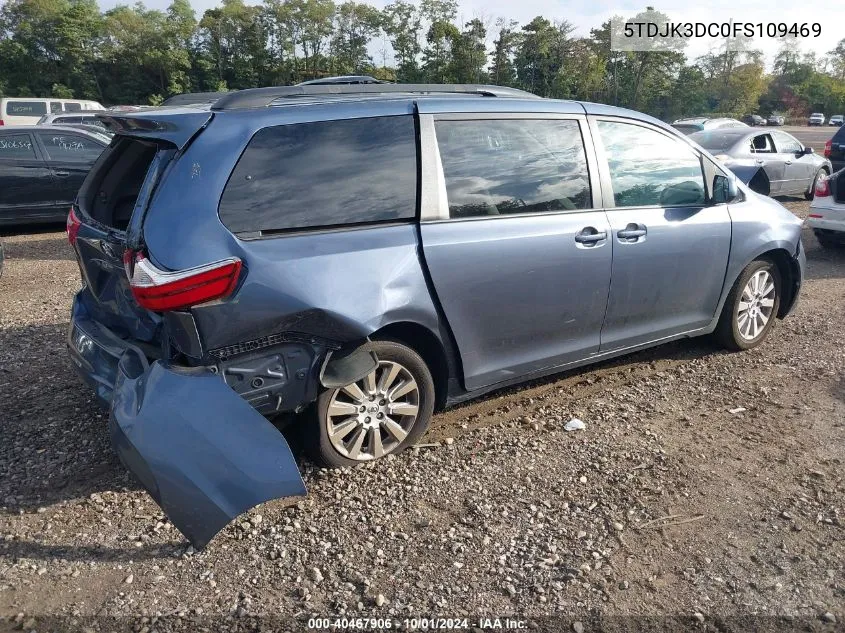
[0,125,109,226]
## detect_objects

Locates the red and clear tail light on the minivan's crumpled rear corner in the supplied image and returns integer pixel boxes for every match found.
[123,251,241,312]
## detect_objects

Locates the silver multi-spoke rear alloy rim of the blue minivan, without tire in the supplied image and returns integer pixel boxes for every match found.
[324,361,420,461]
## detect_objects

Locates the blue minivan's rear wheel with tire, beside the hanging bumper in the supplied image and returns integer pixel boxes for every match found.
[308,340,435,468]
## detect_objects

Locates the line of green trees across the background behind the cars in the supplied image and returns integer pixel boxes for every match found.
[0,0,845,120]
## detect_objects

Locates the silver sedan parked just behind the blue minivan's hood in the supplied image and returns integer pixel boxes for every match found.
[689,128,833,200]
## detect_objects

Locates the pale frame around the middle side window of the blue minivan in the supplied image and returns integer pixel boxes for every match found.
[419,112,603,223]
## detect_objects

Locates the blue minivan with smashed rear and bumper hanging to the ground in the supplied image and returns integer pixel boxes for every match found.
[68,84,804,547]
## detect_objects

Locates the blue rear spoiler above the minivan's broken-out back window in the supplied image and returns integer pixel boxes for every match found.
[97,109,214,149]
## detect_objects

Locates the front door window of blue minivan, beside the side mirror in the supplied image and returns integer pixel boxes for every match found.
[598,121,705,207]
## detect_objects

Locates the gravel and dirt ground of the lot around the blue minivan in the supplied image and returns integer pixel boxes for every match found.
[0,199,845,633]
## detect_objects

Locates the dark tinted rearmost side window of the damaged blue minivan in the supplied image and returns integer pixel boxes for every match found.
[220,116,417,233]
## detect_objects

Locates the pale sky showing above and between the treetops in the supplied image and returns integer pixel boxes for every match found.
[99,0,843,68]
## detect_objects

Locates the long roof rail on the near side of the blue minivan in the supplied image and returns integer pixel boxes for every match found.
[211,84,540,111]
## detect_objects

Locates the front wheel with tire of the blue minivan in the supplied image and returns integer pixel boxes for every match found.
[714,258,782,351]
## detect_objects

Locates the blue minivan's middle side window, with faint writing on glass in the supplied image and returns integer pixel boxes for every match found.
[435,119,592,218]
